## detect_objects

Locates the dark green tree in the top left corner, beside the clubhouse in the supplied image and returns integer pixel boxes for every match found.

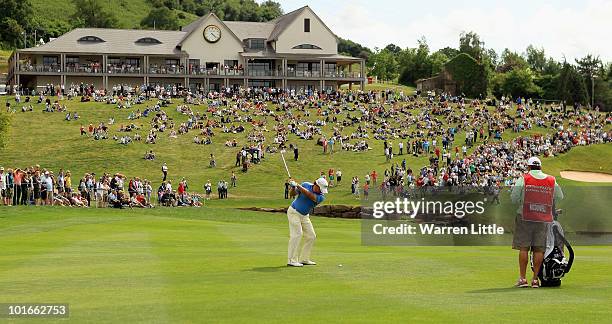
[0,0,33,46]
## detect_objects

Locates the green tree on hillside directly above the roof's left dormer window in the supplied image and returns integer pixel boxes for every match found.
[72,0,117,28]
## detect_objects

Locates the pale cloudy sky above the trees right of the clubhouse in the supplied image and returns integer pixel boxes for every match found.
[268,0,612,62]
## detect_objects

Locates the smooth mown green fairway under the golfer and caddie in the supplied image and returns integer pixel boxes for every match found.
[0,208,612,323]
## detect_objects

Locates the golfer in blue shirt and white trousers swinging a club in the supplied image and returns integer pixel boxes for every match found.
[287,178,328,267]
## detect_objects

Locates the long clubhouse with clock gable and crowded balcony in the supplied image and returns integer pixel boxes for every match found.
[8,6,366,91]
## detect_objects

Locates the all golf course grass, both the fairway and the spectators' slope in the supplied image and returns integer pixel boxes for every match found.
[0,91,612,323]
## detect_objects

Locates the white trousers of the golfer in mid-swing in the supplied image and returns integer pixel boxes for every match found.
[287,206,317,263]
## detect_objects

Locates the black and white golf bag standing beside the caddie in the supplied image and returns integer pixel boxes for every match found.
[531,211,574,287]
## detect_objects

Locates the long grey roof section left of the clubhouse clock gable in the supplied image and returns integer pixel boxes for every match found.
[20,28,185,55]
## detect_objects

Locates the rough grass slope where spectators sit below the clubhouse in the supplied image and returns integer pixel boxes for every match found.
[0,96,612,206]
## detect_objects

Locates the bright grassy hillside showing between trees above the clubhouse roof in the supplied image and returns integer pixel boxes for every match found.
[30,0,197,29]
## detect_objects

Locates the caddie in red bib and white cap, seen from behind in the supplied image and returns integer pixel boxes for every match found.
[512,157,563,288]
